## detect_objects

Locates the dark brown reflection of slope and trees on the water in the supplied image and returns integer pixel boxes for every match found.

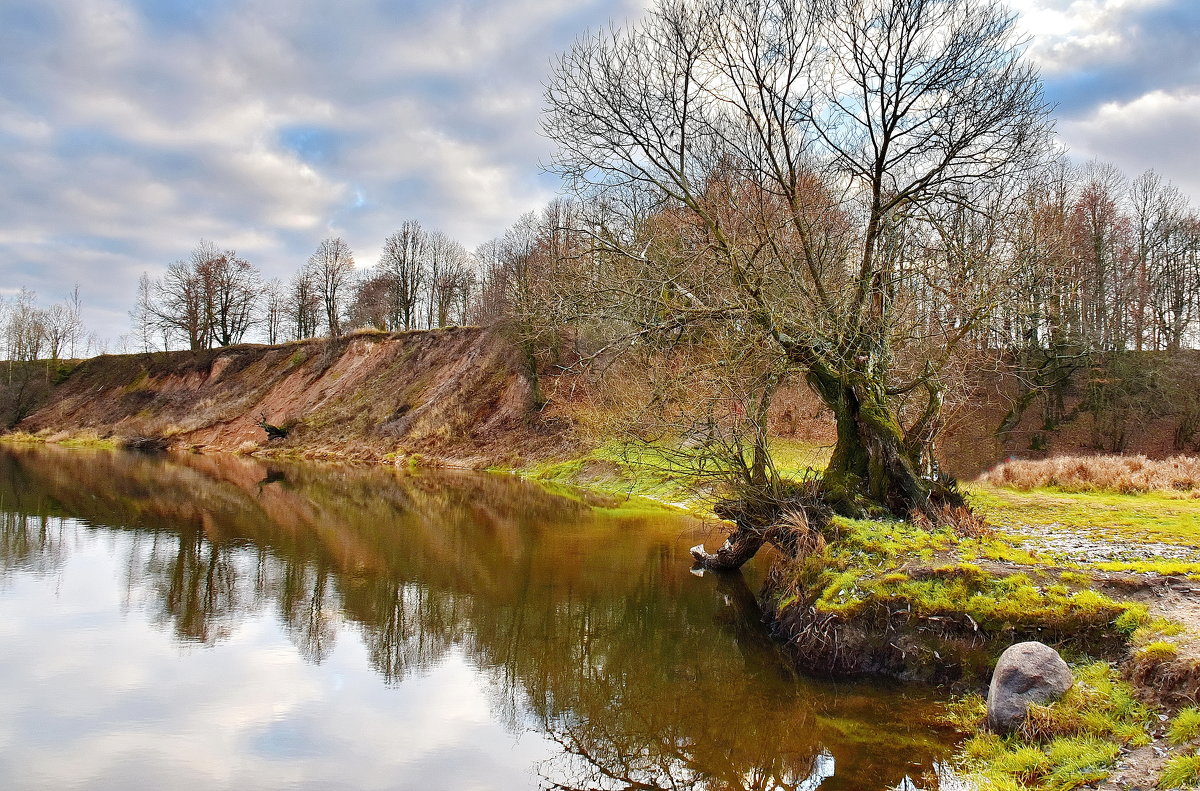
[0,448,942,791]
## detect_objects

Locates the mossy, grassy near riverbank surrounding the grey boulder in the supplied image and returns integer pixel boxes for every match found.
[763,485,1200,790]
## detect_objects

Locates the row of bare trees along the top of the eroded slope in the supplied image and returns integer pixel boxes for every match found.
[131,221,480,350]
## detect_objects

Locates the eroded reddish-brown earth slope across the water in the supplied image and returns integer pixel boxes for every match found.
[8,328,545,467]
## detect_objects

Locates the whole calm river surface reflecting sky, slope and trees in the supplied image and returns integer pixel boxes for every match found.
[0,447,949,791]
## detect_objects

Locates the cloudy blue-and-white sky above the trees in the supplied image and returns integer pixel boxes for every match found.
[0,0,1200,352]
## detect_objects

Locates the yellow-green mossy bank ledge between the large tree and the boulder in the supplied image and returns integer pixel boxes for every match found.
[772,519,1151,679]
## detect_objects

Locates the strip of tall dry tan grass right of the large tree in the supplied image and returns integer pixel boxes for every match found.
[980,456,1200,497]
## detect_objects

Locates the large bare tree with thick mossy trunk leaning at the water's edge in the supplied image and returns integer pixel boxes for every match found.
[544,0,1049,565]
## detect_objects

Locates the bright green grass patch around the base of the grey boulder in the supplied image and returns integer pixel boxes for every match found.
[946,663,1153,791]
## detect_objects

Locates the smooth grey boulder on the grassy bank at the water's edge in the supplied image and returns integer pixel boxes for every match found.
[988,641,1073,735]
